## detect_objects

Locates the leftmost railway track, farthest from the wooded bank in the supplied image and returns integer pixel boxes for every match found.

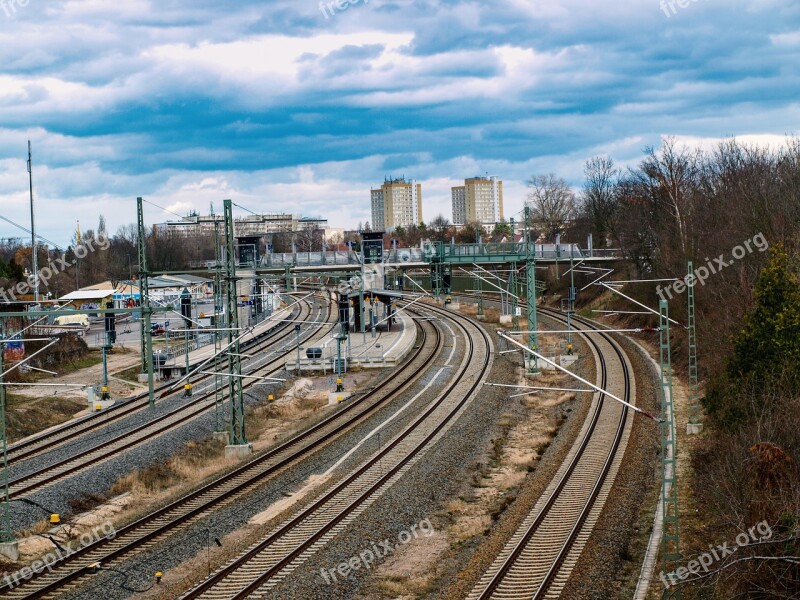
[8,292,312,466]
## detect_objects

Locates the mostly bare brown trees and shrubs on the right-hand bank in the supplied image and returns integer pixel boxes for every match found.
[578,137,800,598]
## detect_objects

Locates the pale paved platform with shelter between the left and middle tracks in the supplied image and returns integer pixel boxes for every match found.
[286,310,417,373]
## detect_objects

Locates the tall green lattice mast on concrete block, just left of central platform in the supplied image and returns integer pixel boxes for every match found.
[224,200,253,456]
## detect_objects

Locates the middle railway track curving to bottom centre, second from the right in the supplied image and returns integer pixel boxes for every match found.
[181,307,492,599]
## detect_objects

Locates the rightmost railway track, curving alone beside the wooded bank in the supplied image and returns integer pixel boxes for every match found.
[468,310,635,600]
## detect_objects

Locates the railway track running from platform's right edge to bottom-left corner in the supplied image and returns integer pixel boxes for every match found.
[0,304,450,598]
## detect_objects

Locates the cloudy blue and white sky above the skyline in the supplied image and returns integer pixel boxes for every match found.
[0,0,800,244]
